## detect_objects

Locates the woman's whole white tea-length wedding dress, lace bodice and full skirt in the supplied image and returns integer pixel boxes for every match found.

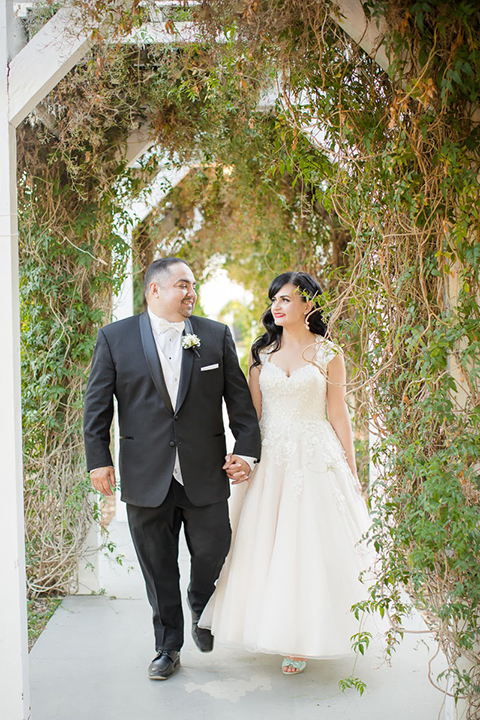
[199,336,372,658]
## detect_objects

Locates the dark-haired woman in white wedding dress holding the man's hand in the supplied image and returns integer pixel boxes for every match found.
[199,272,370,674]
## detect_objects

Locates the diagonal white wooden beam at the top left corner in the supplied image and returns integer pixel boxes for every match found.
[8,6,90,127]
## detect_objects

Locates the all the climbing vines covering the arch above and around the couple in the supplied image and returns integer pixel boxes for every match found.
[20,0,480,720]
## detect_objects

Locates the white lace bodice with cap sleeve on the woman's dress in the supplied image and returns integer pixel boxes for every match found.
[260,336,346,492]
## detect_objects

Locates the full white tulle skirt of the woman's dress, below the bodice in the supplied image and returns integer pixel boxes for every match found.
[200,428,373,658]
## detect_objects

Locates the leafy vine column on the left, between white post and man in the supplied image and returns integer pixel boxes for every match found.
[18,45,159,598]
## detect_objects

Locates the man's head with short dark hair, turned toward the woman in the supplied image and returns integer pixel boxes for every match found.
[147,263,197,322]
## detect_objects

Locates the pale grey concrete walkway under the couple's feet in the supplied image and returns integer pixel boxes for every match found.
[30,522,453,720]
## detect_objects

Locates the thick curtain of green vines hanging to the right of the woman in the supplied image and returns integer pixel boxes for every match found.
[188,1,480,717]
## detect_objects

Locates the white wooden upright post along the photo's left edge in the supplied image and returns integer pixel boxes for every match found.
[0,0,31,720]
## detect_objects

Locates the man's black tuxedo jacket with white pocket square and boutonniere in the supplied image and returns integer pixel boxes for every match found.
[84,313,260,507]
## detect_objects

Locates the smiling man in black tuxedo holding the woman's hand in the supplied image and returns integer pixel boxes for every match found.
[84,258,260,680]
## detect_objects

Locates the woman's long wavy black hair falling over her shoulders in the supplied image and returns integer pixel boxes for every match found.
[250,270,328,370]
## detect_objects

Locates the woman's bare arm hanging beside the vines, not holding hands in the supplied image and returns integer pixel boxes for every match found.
[327,354,358,477]
